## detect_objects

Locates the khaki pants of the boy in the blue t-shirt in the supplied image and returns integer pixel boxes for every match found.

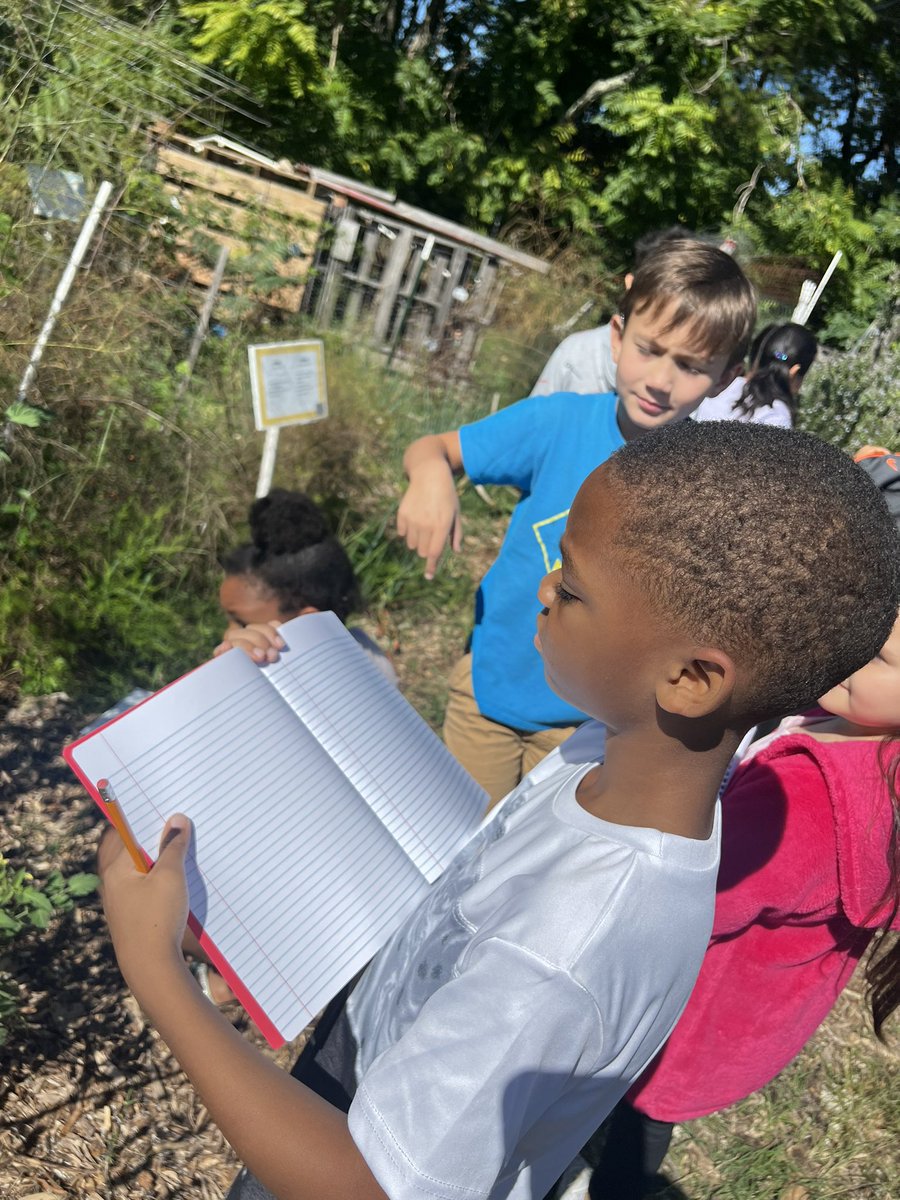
[444,654,576,808]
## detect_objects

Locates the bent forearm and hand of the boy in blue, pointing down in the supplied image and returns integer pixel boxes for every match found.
[397,431,462,580]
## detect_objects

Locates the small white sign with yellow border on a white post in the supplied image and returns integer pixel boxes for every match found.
[247,338,328,499]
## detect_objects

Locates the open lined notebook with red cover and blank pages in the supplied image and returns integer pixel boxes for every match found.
[64,613,487,1046]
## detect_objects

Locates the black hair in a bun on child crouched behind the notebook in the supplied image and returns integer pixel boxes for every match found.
[222,487,360,620]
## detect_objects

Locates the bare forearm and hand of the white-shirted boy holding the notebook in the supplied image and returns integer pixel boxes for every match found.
[98,817,385,1200]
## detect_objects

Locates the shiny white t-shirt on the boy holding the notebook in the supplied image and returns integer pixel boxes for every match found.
[348,721,719,1200]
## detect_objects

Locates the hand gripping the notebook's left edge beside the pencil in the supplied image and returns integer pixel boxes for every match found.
[97,815,191,990]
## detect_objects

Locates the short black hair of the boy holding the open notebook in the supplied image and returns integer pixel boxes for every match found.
[607,421,900,721]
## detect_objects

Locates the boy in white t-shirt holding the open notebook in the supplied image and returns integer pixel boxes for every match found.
[100,422,900,1200]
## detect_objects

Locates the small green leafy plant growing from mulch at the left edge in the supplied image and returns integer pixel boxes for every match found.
[0,856,98,1046]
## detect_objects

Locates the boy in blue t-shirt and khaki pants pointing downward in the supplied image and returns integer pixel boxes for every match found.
[397,239,756,803]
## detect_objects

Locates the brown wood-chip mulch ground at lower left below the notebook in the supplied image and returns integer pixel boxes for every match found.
[0,696,309,1200]
